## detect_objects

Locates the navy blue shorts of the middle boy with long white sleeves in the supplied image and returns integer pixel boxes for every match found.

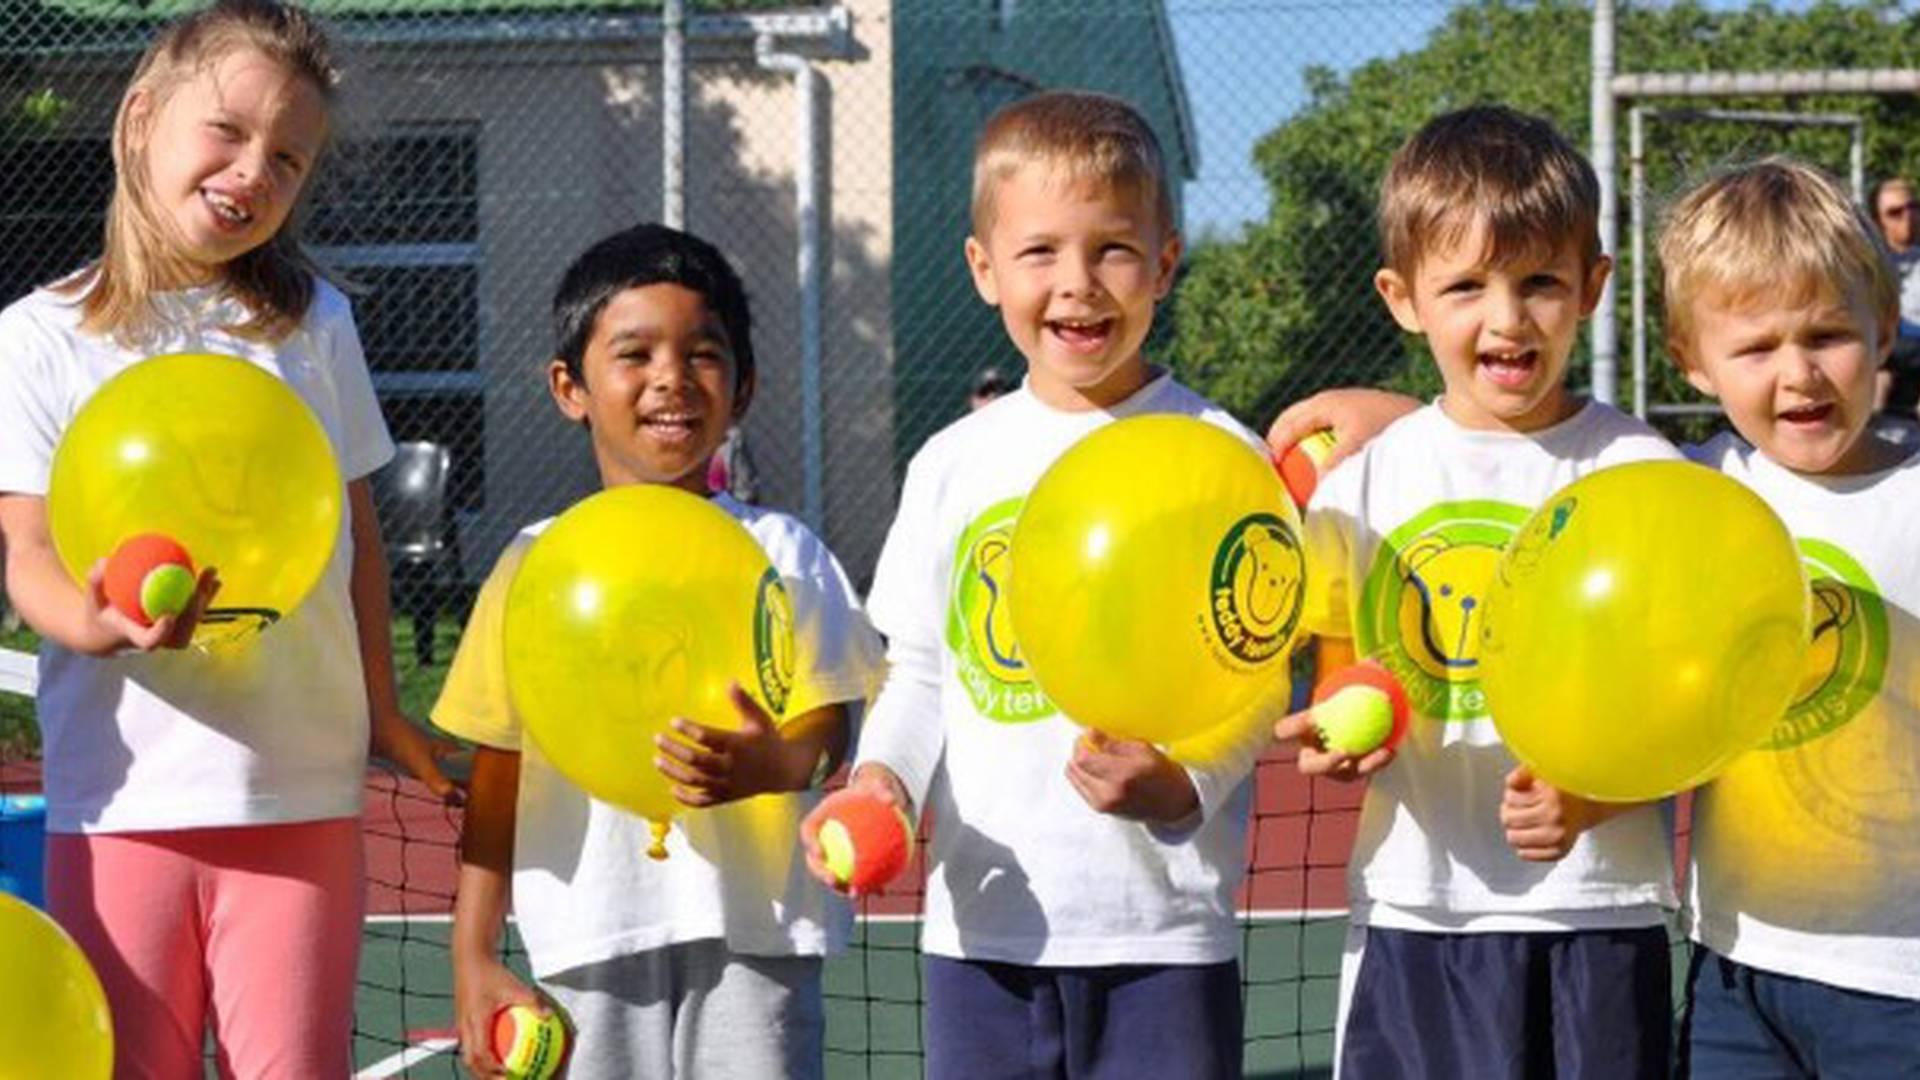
[925,957,1242,1080]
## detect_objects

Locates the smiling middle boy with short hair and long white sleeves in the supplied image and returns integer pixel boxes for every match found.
[803,92,1265,1080]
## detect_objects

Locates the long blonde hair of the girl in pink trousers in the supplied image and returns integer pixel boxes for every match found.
[58,0,338,342]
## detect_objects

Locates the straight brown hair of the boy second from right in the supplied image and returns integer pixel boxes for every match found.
[1380,106,1601,277]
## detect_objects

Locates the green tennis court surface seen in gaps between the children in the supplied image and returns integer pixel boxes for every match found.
[355,917,1346,1080]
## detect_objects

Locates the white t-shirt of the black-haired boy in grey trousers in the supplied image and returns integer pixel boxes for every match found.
[434,496,881,978]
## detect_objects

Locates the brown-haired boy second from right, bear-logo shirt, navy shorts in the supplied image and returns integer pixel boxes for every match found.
[1275,106,1674,1080]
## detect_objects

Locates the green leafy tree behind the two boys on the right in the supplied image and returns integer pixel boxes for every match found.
[1171,0,1920,427]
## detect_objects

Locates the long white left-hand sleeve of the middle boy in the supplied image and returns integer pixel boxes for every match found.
[854,449,947,811]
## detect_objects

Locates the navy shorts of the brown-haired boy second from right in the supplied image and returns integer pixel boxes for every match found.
[1340,926,1674,1080]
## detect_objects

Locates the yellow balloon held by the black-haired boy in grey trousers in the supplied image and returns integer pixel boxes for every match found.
[505,484,793,857]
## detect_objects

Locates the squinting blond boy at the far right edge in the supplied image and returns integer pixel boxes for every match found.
[1659,158,1920,1078]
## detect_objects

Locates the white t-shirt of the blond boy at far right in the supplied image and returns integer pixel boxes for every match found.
[1690,434,1920,999]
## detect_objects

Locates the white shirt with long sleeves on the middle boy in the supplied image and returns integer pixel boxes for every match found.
[860,375,1284,967]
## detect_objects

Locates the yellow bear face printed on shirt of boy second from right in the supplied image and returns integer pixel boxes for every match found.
[1396,534,1500,682]
